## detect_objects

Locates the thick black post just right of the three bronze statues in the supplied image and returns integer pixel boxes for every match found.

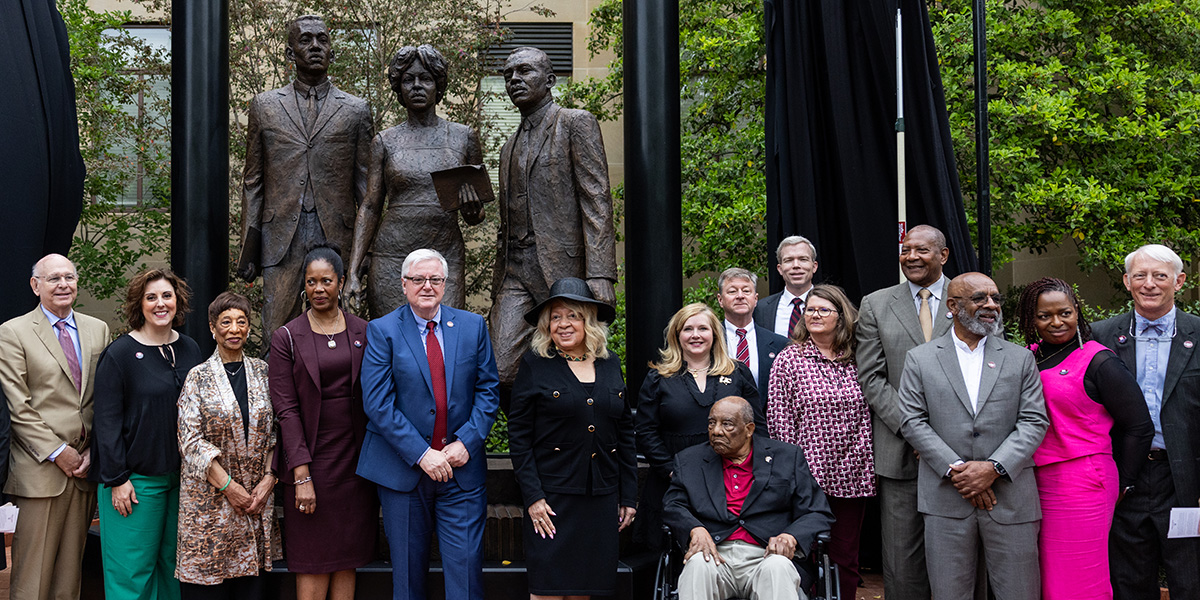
[624,0,683,400]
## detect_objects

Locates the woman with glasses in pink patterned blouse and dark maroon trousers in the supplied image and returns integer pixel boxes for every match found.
[767,284,875,596]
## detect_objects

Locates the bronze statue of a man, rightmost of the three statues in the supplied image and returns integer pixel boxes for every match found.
[488,47,617,385]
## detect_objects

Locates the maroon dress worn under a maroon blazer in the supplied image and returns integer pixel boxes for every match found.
[283,331,379,574]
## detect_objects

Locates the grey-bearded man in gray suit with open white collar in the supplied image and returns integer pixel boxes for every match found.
[900,272,1049,600]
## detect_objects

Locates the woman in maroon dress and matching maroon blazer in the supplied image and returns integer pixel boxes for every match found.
[269,246,379,600]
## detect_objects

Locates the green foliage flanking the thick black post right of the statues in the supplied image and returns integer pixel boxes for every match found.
[563,0,767,304]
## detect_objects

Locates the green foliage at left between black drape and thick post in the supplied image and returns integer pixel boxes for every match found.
[59,0,170,316]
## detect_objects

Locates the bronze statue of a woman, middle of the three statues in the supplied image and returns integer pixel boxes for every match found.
[348,44,484,318]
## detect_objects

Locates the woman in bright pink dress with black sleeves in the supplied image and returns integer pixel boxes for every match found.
[1020,277,1154,600]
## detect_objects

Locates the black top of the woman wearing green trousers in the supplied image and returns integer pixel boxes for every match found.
[90,334,203,487]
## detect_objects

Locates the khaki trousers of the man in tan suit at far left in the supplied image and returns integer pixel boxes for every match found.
[10,480,96,600]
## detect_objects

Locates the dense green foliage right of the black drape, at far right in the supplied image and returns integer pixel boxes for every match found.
[930,0,1200,280]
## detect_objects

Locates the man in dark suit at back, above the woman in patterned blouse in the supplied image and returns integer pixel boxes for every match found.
[754,235,817,337]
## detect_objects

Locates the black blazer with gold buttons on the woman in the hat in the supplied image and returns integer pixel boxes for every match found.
[509,350,637,506]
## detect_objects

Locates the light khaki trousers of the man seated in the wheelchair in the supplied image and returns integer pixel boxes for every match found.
[679,541,808,600]
